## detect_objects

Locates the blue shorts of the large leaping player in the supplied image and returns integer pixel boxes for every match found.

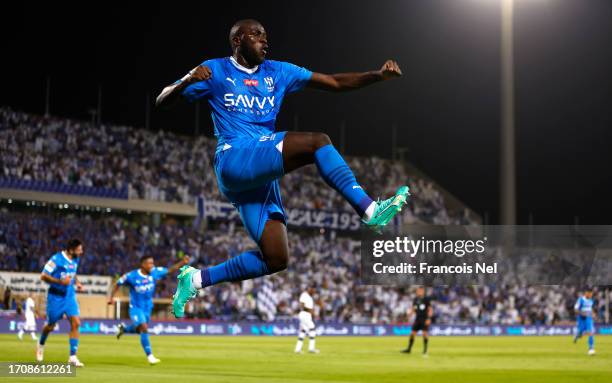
[215,132,287,243]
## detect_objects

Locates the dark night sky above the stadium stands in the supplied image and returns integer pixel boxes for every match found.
[0,0,612,224]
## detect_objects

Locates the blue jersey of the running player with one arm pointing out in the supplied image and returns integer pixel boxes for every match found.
[117,267,168,309]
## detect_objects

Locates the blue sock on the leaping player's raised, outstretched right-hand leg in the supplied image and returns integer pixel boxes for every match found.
[315,144,373,217]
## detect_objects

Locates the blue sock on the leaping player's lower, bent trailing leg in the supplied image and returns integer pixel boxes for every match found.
[201,251,270,287]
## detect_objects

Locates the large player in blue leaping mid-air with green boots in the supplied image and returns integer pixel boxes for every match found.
[156,20,409,318]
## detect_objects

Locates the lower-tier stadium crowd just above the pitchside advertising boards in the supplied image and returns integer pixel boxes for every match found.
[0,209,604,324]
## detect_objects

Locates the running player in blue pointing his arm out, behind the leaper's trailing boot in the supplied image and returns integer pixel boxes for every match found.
[108,255,189,365]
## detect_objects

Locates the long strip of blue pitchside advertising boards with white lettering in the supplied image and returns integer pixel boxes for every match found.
[0,318,612,336]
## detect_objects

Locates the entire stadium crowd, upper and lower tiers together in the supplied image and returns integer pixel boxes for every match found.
[0,107,605,324]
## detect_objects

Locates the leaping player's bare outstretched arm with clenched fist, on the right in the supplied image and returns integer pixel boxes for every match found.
[307,60,402,92]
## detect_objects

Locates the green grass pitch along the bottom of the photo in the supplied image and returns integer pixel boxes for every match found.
[0,334,612,383]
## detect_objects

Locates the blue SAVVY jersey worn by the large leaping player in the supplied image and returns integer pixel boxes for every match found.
[178,57,312,153]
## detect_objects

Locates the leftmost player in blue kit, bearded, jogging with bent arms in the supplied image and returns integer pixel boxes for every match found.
[36,239,84,367]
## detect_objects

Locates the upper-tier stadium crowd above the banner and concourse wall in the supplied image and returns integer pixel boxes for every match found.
[0,107,473,224]
